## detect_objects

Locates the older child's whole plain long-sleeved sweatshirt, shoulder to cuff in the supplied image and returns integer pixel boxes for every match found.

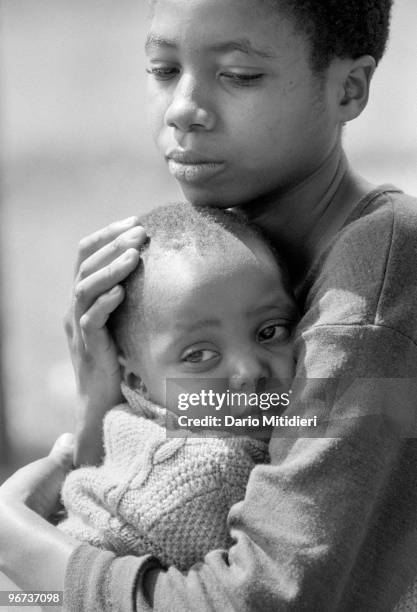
[65,187,417,612]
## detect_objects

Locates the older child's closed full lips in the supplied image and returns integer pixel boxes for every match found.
[166,151,225,184]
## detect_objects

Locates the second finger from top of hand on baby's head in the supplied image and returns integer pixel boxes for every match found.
[77,226,147,281]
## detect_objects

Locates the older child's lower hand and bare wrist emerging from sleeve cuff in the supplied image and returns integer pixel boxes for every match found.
[0,435,79,591]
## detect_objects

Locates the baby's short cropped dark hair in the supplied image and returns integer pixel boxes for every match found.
[108,202,291,355]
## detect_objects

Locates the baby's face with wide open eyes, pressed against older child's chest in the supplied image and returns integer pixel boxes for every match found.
[128,240,296,408]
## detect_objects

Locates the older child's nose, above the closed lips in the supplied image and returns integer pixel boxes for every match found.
[165,75,215,132]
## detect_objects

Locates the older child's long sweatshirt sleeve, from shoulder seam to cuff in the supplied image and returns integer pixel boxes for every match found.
[66,325,417,612]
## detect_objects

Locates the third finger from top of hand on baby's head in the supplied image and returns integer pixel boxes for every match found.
[74,249,140,321]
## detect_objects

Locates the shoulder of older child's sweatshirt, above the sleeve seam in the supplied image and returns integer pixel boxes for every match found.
[305,186,417,339]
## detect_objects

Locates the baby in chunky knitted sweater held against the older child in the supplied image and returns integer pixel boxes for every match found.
[61,204,297,570]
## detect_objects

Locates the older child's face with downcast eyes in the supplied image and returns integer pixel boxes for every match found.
[146,0,338,207]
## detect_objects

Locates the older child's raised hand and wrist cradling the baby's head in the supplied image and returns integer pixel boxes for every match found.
[65,217,146,464]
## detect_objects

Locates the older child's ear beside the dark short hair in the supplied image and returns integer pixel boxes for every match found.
[339,55,376,122]
